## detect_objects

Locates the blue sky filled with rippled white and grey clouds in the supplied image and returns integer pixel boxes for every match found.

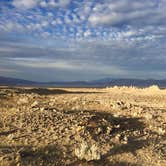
[0,0,166,82]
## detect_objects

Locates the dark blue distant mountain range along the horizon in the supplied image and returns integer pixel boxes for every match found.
[0,76,166,87]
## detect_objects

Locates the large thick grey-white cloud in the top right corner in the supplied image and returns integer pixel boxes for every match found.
[89,0,166,26]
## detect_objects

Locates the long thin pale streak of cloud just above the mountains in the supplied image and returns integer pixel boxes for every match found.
[8,58,127,75]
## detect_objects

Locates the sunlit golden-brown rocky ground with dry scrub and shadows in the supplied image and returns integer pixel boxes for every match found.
[0,86,166,166]
